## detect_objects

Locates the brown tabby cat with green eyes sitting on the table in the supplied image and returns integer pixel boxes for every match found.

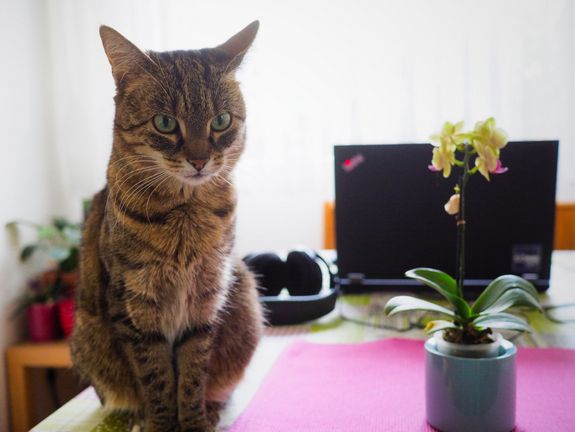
[71,21,263,432]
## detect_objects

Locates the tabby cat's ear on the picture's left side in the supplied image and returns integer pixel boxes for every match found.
[100,25,151,84]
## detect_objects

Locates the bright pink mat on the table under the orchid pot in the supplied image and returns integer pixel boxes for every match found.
[229,339,575,432]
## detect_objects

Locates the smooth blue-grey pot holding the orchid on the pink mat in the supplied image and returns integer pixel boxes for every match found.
[425,338,517,432]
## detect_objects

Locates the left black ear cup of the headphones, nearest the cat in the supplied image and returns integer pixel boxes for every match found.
[244,253,287,296]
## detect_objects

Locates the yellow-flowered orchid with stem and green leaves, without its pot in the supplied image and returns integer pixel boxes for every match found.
[385,118,541,344]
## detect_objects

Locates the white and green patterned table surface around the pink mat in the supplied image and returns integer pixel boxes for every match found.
[32,252,575,432]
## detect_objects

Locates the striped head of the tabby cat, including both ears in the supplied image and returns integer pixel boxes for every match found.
[100,22,257,186]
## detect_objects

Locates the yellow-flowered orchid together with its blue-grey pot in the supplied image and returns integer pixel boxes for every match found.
[385,118,541,432]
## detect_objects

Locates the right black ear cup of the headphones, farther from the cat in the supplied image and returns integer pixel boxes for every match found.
[286,251,323,296]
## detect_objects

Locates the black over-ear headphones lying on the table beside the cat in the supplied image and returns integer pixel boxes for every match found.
[244,250,337,325]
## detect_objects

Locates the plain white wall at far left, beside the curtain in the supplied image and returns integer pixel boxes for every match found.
[0,0,56,432]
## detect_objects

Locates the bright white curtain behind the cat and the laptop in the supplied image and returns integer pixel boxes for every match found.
[42,0,575,253]
